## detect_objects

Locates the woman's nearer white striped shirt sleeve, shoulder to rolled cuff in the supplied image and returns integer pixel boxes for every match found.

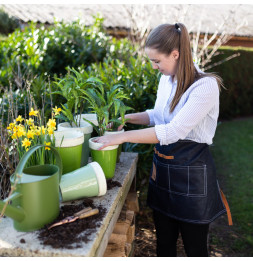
[155,77,219,145]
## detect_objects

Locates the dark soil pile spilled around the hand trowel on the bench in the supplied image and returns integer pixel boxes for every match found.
[38,199,106,249]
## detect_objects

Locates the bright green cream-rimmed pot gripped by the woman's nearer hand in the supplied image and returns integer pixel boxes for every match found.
[89,137,118,179]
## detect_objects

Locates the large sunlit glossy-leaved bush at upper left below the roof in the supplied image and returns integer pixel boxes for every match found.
[0,17,110,87]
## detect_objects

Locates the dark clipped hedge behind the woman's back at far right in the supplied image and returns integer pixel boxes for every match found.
[207,48,253,119]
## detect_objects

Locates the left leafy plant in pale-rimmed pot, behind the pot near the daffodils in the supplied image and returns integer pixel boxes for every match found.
[52,67,101,166]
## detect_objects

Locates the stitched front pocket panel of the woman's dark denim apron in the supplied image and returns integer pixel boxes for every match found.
[154,160,207,197]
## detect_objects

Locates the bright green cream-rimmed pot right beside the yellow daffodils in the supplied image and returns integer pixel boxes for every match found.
[54,130,84,174]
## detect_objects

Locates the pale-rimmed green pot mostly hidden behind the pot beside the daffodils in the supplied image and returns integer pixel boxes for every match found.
[57,121,93,166]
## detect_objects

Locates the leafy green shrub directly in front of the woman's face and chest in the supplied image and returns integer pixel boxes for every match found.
[86,57,160,112]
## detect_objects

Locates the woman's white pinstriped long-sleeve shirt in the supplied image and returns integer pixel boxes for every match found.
[147,72,219,145]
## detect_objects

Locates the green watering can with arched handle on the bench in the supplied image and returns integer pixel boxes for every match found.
[0,145,62,232]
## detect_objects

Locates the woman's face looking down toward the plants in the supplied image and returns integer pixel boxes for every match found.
[145,48,179,76]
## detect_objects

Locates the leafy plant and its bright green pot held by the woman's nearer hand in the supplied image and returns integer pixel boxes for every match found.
[82,83,127,179]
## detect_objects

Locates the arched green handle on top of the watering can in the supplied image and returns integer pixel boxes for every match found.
[15,144,62,180]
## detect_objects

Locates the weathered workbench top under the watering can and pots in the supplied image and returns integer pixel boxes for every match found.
[0,152,138,257]
